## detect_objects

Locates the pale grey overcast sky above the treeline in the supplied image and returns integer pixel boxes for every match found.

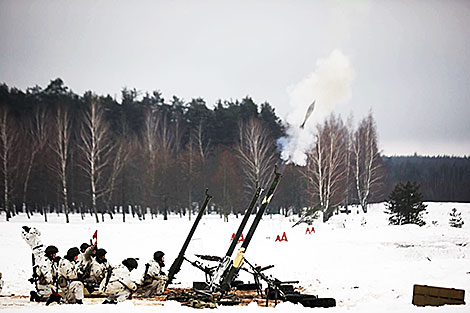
[0,0,470,155]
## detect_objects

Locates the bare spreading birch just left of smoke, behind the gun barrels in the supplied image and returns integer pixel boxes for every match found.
[235,118,277,194]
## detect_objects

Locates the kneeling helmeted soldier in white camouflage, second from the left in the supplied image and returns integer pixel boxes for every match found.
[58,247,83,304]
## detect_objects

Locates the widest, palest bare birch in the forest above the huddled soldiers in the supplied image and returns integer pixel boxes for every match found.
[80,96,113,223]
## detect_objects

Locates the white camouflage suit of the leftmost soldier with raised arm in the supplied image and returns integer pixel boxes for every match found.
[21,227,57,301]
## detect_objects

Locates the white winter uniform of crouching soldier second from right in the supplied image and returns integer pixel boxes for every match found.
[100,264,137,302]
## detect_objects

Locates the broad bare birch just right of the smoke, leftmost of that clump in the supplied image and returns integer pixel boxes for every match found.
[305,114,347,221]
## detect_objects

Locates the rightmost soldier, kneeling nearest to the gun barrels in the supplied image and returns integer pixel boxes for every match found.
[141,251,168,297]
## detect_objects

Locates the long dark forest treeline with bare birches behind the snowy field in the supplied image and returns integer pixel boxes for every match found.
[0,79,470,222]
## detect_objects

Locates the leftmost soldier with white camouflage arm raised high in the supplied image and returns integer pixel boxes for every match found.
[21,226,60,302]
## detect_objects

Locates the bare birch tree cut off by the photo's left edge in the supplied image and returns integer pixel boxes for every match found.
[0,106,19,222]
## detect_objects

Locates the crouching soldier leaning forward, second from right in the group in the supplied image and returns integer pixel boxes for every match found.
[100,258,138,304]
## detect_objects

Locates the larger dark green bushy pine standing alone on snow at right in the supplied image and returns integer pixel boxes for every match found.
[386,181,426,226]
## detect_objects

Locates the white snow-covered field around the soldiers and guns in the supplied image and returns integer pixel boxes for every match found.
[0,203,470,312]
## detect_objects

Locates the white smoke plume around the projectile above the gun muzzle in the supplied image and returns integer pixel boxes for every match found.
[278,50,354,166]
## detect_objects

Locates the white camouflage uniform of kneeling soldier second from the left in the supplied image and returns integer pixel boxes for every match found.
[59,258,83,303]
